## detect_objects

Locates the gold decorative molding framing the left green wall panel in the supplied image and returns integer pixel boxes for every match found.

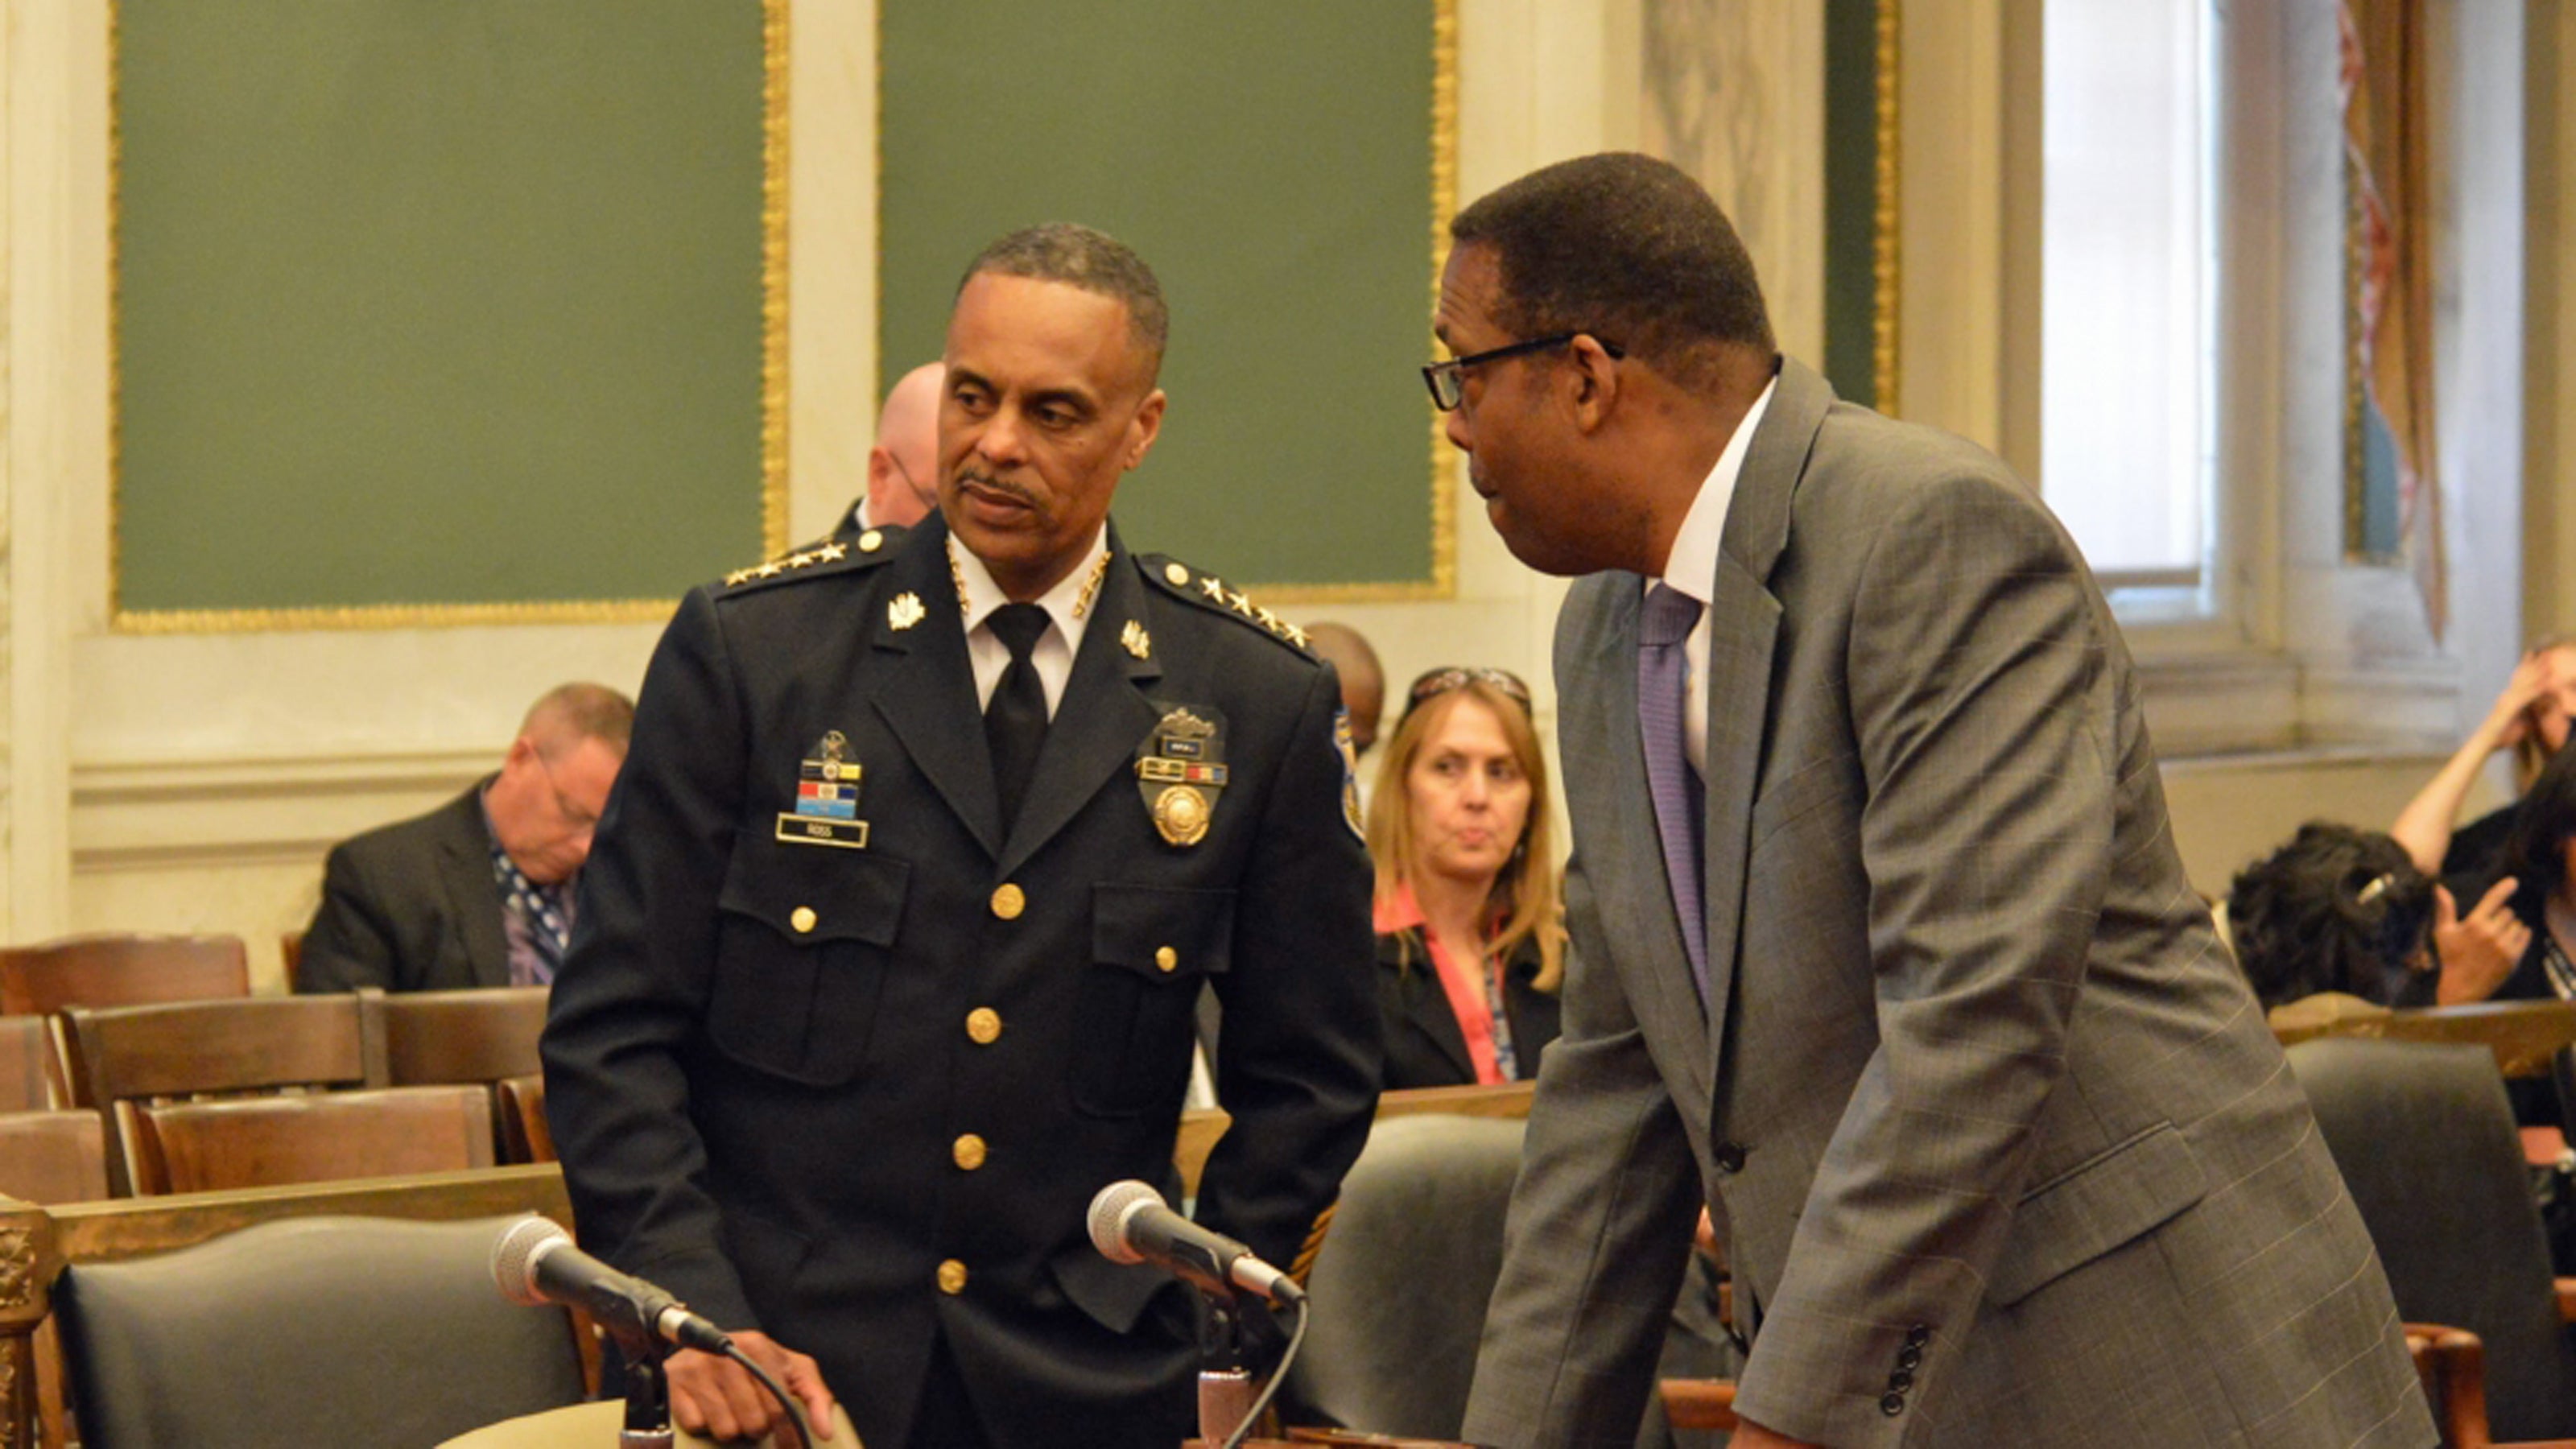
[108,0,793,634]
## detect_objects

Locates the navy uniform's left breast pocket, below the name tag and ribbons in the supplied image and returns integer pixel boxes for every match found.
[706,840,912,1085]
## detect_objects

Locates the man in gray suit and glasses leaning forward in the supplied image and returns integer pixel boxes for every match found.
[1427,155,2434,1449]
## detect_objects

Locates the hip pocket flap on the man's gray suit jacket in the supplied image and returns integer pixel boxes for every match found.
[1986,1121,2211,1307]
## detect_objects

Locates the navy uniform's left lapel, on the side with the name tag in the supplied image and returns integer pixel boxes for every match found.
[868,513,1014,856]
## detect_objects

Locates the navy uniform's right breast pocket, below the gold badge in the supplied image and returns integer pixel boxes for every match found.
[1071,885,1234,1117]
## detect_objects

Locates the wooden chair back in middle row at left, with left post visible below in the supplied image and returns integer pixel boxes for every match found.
[62,988,386,1194]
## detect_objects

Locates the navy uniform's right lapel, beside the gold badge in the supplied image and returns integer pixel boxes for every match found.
[979,526,1162,874]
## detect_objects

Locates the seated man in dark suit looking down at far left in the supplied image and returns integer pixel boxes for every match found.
[294,683,636,993]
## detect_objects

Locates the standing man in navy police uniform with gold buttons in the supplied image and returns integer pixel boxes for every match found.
[543,225,1378,1449]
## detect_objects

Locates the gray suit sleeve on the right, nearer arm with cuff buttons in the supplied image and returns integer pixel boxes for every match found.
[1736,474,2120,1447]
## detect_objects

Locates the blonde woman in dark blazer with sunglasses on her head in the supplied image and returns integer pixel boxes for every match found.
[1368,668,1567,1091]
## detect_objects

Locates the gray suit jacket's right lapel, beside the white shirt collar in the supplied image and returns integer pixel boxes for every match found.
[1700,361,1834,1042]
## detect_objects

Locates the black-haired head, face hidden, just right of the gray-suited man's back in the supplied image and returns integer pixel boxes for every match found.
[2228,820,2439,1011]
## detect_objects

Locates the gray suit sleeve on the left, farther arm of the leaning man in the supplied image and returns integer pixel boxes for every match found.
[1466,859,1703,1449]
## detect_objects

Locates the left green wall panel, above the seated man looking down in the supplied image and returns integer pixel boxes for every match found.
[116,0,765,613]
